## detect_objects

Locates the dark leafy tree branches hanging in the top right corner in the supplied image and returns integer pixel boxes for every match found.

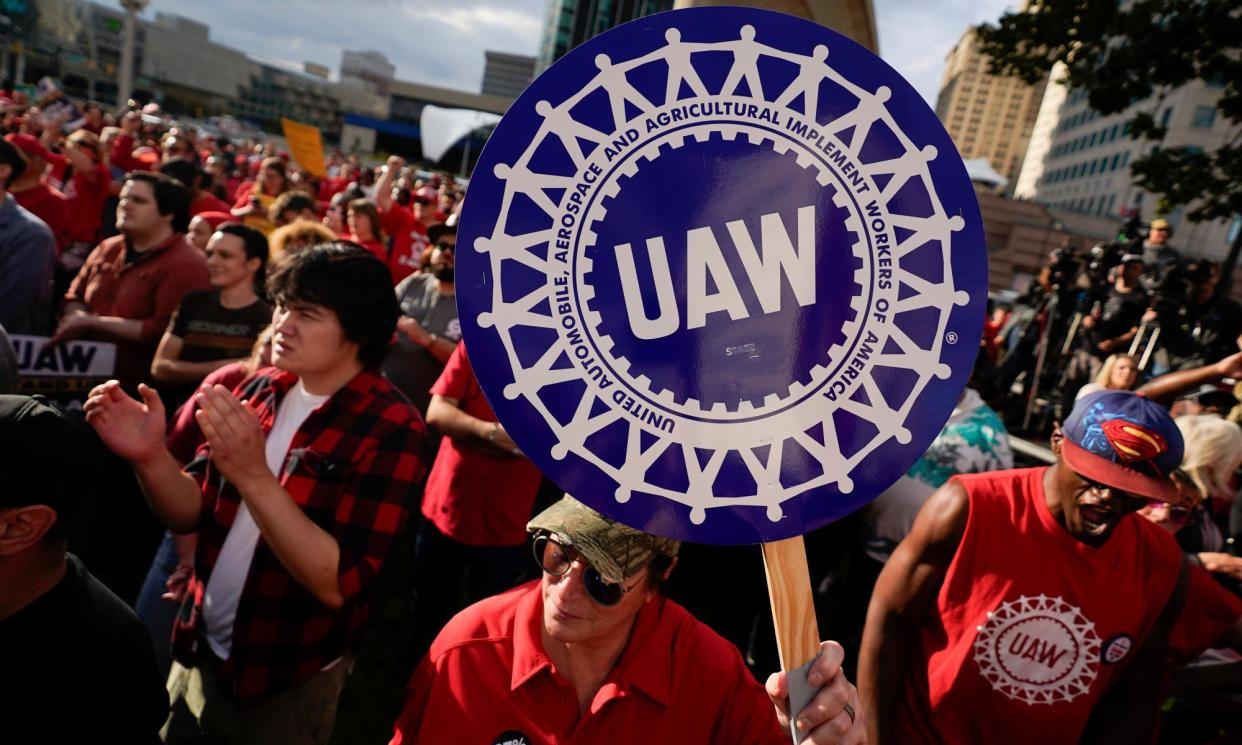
[977,0,1242,221]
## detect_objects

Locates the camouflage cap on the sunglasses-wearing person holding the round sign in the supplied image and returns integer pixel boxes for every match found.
[527,494,682,584]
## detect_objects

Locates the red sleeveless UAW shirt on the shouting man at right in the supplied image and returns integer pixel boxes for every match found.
[894,468,1195,745]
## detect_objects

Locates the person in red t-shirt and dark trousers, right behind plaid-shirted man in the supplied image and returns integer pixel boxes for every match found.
[414,344,543,649]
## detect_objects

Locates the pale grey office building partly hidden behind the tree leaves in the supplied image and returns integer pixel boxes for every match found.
[1016,77,1238,260]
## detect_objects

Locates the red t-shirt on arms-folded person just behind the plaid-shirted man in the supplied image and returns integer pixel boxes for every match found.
[422,344,543,546]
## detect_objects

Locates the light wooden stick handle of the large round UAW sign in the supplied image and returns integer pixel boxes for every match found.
[763,535,820,743]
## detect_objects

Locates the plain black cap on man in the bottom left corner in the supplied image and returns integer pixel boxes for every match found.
[0,395,104,522]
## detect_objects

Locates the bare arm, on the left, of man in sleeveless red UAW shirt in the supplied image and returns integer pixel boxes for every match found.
[858,481,970,745]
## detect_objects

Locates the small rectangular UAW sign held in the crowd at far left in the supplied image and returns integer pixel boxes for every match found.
[10,335,117,406]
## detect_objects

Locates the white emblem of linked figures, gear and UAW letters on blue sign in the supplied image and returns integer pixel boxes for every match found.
[473,25,969,524]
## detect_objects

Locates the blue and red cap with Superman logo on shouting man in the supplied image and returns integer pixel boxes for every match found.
[1061,391,1182,502]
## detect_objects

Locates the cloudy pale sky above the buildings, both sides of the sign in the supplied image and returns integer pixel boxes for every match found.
[144,0,1016,104]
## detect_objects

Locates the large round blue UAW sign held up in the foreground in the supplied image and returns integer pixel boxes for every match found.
[457,7,987,544]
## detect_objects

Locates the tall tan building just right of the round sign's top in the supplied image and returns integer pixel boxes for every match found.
[935,29,1046,190]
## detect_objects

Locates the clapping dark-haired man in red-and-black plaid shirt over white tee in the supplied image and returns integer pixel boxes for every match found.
[87,245,425,743]
